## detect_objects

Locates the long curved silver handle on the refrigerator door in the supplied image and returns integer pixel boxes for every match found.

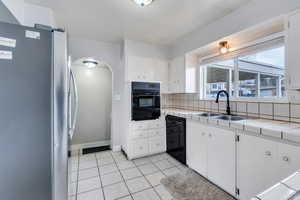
[69,69,79,139]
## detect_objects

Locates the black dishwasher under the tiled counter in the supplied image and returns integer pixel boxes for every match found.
[166,115,186,165]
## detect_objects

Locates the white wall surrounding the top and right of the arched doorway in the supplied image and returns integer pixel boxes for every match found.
[69,37,125,149]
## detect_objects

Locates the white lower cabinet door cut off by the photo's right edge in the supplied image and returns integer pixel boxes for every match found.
[278,143,300,180]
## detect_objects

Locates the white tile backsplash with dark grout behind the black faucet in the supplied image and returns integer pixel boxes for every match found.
[161,94,300,123]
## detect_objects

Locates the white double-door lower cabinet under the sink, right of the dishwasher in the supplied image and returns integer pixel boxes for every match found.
[187,120,236,195]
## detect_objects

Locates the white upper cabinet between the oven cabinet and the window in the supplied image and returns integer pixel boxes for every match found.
[169,55,198,93]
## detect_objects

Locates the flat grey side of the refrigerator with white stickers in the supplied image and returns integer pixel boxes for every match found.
[0,23,52,200]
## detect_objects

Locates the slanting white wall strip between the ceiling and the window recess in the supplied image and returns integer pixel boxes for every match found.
[171,0,300,57]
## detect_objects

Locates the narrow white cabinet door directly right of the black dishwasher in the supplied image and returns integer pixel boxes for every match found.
[186,120,207,177]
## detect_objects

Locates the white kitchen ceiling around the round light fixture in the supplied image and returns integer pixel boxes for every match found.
[26,0,251,45]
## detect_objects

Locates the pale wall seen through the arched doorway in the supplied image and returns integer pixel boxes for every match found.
[72,65,112,145]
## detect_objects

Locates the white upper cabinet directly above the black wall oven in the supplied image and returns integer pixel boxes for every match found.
[126,56,168,93]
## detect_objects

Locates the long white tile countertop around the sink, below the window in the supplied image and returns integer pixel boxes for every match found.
[162,109,300,144]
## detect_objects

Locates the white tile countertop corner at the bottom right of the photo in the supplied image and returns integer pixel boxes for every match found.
[251,171,300,200]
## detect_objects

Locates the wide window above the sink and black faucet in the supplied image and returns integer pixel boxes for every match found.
[200,46,286,98]
